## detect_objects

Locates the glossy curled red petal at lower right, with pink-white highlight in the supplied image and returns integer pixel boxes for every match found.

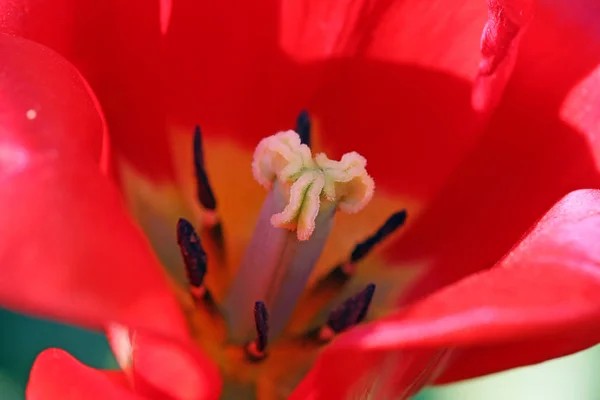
[298,190,600,399]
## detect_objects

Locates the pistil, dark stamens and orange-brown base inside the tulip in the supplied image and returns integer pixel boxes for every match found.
[169,111,407,399]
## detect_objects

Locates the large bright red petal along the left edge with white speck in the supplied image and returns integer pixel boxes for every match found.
[0,35,187,337]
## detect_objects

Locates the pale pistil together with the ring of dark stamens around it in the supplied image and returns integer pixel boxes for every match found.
[177,112,406,396]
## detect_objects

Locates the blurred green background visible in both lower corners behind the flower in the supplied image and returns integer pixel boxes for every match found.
[0,309,600,400]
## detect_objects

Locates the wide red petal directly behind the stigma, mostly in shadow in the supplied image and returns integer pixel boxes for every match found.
[166,0,486,205]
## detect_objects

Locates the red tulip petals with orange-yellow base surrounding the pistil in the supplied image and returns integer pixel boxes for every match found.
[0,0,600,399]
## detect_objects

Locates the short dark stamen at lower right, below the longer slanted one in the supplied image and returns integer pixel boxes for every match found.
[319,283,375,341]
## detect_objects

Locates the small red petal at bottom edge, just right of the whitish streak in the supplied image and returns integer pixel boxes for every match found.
[131,332,221,400]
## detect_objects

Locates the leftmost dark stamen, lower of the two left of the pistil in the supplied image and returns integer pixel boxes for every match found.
[177,218,218,313]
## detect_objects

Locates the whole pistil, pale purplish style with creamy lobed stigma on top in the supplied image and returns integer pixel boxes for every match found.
[225,131,375,342]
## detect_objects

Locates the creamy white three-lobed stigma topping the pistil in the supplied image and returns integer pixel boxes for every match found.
[252,131,375,241]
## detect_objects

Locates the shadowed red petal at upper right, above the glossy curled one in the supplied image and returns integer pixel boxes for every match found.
[389,0,600,301]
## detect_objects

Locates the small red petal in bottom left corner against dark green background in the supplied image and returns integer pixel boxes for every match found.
[27,349,142,400]
